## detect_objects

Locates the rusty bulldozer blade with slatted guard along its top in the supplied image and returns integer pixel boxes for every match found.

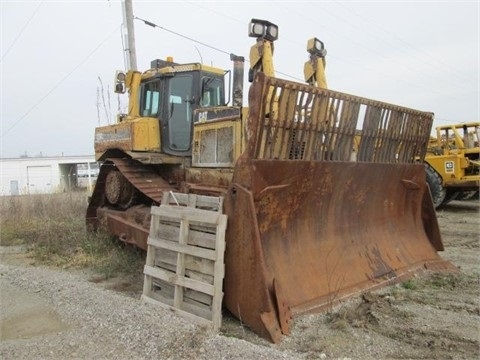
[224,74,455,342]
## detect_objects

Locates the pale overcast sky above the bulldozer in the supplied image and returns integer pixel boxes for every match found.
[0,0,480,158]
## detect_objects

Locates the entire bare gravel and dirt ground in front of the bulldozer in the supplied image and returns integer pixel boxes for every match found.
[0,201,480,360]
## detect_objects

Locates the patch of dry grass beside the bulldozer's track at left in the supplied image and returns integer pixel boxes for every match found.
[0,192,144,278]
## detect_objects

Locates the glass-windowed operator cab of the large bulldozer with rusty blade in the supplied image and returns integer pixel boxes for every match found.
[117,60,230,156]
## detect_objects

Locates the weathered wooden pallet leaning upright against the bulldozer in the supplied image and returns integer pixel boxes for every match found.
[142,192,227,330]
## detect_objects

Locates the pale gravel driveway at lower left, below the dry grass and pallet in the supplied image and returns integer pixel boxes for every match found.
[0,258,301,360]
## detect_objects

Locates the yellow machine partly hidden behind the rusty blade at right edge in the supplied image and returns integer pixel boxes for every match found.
[425,122,480,208]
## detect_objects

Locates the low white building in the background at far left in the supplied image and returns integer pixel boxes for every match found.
[0,156,99,196]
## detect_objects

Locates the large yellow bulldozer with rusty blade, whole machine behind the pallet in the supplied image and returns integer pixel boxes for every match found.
[86,19,455,343]
